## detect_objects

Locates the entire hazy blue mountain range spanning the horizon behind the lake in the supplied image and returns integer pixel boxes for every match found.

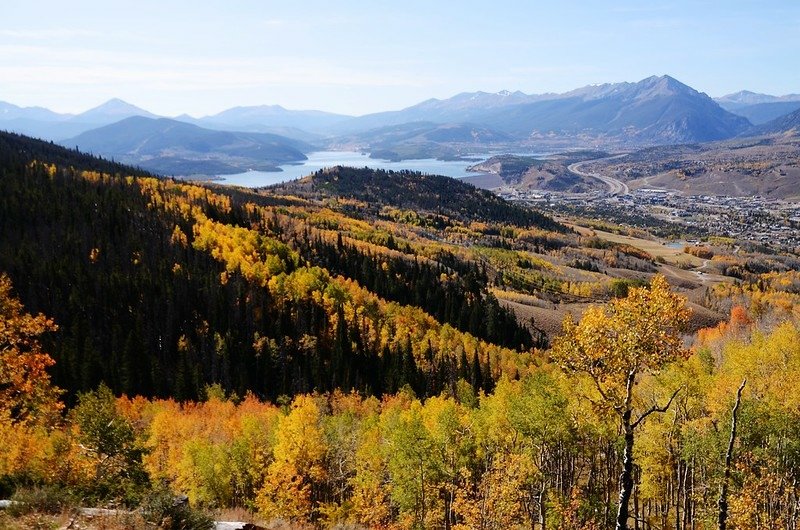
[0,75,800,174]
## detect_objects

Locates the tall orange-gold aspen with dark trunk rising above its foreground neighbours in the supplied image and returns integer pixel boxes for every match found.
[552,275,690,530]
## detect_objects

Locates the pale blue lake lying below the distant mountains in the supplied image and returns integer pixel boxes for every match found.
[215,151,483,188]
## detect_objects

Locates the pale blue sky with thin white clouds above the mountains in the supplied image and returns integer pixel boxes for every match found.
[0,0,800,116]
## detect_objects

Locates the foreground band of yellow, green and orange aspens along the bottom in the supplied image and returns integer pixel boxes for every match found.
[0,268,800,529]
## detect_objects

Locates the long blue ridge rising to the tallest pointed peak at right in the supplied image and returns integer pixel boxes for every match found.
[338,75,750,144]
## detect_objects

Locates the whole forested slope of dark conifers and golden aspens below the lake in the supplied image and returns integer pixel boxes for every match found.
[0,129,800,530]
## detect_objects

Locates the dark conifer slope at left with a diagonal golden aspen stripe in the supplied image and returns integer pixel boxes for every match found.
[0,132,533,398]
